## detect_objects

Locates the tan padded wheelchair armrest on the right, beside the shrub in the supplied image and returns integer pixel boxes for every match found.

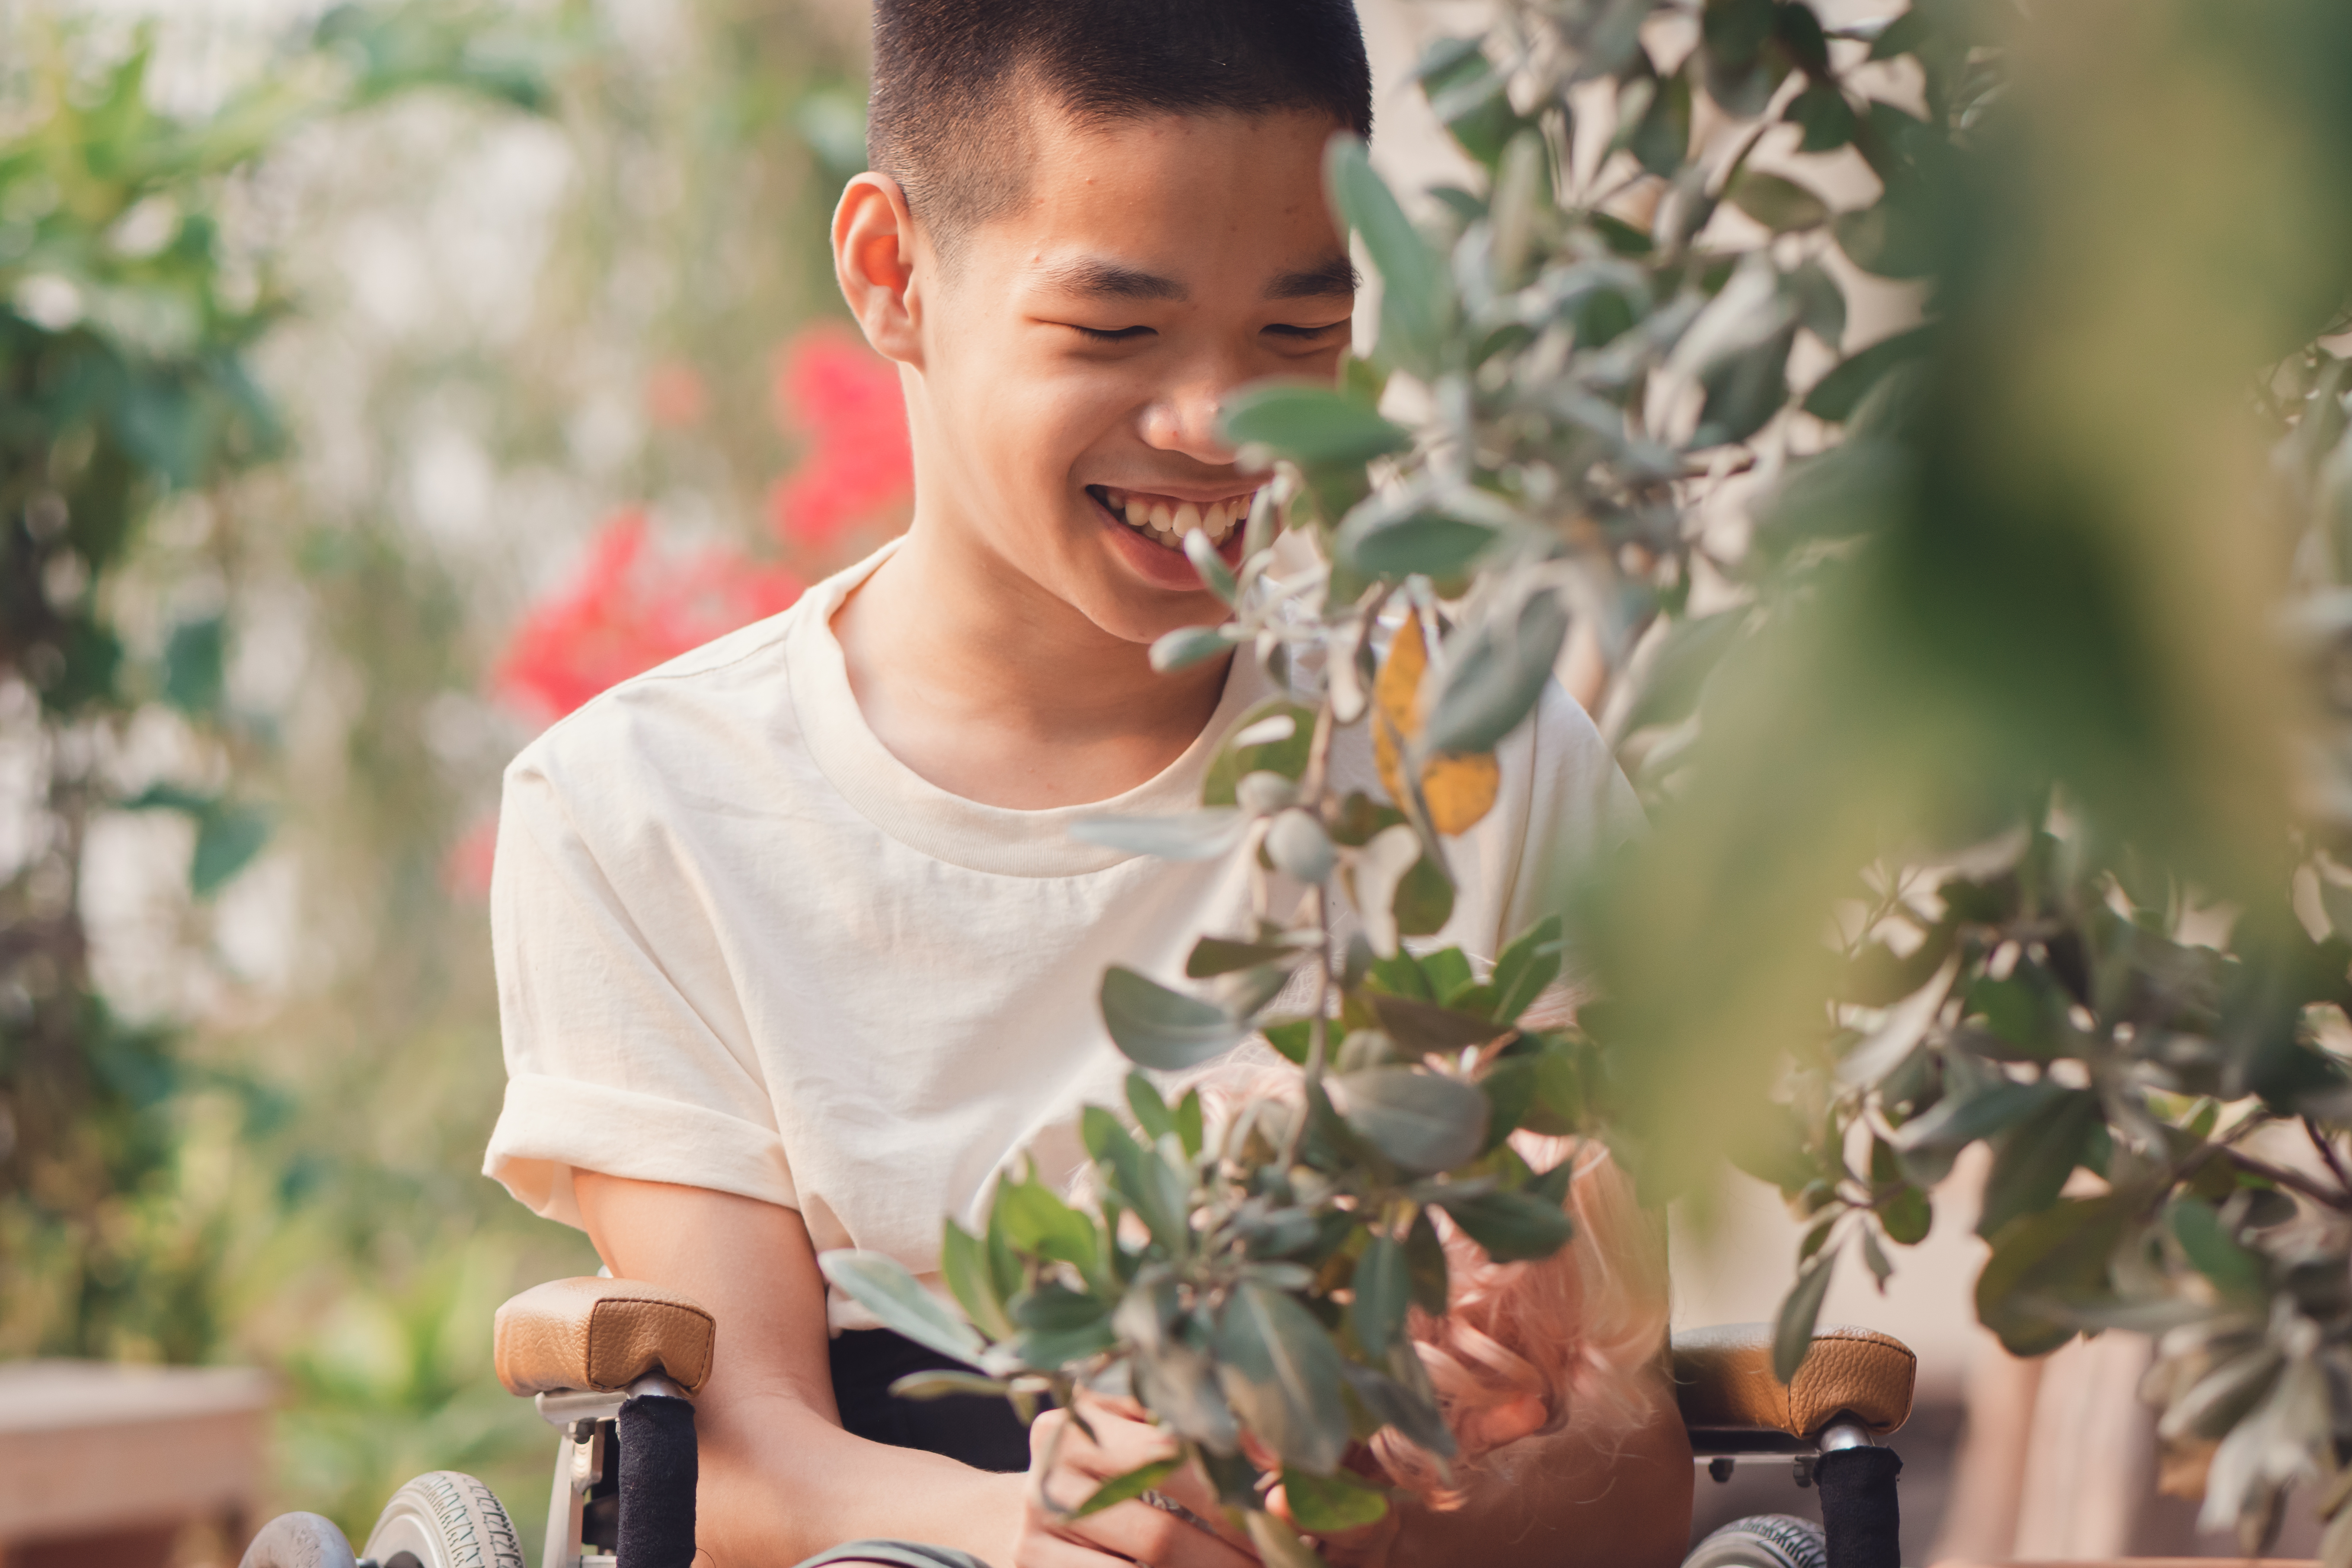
[1675,1323,1919,1439]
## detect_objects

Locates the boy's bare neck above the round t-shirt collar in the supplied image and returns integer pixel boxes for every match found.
[833,522,1225,809]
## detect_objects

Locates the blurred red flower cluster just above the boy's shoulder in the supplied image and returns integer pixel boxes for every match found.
[496,510,800,722]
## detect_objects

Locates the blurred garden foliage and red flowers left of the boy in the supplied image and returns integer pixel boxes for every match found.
[0,0,903,1535]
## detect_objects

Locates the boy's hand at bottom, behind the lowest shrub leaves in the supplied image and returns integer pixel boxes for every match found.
[1011,1392,1258,1568]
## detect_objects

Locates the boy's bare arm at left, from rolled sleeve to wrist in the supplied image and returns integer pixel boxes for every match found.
[574,1171,1023,1563]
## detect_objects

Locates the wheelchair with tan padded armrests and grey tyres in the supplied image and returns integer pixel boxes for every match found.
[240,1279,1917,1568]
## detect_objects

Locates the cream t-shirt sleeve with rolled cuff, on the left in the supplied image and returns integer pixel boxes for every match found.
[482,745,797,1225]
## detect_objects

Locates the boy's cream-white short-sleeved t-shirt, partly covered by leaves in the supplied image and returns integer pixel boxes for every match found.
[485,550,1639,1331]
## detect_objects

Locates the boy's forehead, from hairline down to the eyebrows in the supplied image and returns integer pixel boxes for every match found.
[988,108,1355,301]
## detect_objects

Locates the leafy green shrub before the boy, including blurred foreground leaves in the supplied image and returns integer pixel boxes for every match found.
[835,0,2352,1563]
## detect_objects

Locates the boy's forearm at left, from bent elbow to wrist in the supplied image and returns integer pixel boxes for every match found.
[696,1399,1023,1568]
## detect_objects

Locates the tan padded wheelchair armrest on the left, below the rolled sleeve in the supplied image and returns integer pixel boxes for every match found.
[494,1279,717,1394]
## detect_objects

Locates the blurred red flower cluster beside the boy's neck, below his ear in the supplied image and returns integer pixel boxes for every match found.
[767,324,915,550]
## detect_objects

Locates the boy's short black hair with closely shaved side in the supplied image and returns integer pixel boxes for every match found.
[866,0,1371,249]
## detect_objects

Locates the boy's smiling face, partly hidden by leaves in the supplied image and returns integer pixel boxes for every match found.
[908,111,1355,642]
